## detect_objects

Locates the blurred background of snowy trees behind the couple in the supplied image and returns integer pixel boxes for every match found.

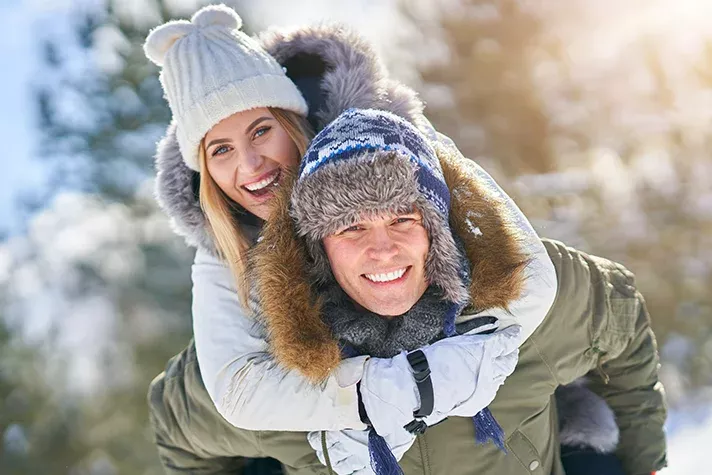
[0,0,712,475]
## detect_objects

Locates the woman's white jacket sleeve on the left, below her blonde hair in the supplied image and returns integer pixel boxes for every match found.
[192,250,366,431]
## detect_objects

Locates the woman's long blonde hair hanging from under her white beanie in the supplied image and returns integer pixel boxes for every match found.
[198,107,314,305]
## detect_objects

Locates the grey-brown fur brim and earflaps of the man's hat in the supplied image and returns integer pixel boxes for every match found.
[291,152,469,304]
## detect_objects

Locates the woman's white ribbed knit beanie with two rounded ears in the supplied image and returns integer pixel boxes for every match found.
[144,5,307,171]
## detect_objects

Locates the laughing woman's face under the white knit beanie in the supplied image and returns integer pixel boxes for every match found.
[204,107,300,219]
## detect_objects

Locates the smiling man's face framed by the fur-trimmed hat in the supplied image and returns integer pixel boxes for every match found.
[324,211,430,316]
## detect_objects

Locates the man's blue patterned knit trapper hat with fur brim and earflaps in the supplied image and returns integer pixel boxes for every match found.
[290,109,469,304]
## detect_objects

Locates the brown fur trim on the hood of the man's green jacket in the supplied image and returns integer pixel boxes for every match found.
[250,148,527,382]
